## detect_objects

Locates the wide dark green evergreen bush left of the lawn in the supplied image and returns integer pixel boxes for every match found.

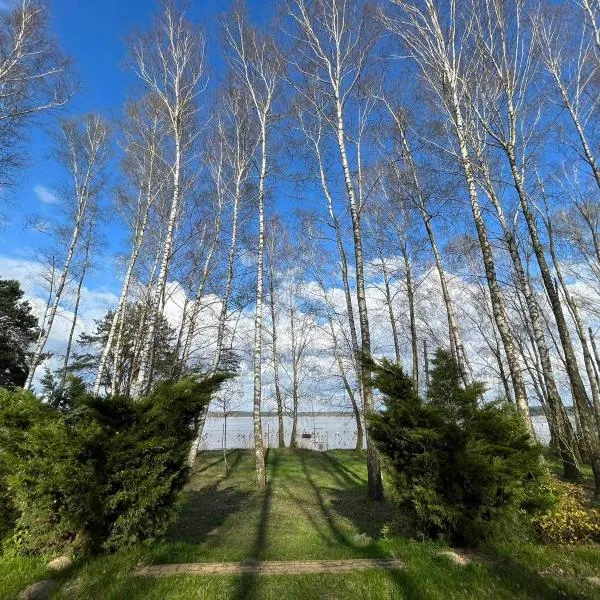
[0,375,224,552]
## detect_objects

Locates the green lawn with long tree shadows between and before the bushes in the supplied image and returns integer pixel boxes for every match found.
[0,450,600,600]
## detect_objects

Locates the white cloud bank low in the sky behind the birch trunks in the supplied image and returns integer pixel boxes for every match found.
[0,248,600,418]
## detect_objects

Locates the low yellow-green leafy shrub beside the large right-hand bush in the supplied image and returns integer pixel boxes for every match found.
[533,480,600,544]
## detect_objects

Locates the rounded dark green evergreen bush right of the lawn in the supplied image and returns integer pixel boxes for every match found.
[369,350,547,544]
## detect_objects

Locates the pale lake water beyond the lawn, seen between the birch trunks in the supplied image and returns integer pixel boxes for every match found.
[200,414,550,450]
